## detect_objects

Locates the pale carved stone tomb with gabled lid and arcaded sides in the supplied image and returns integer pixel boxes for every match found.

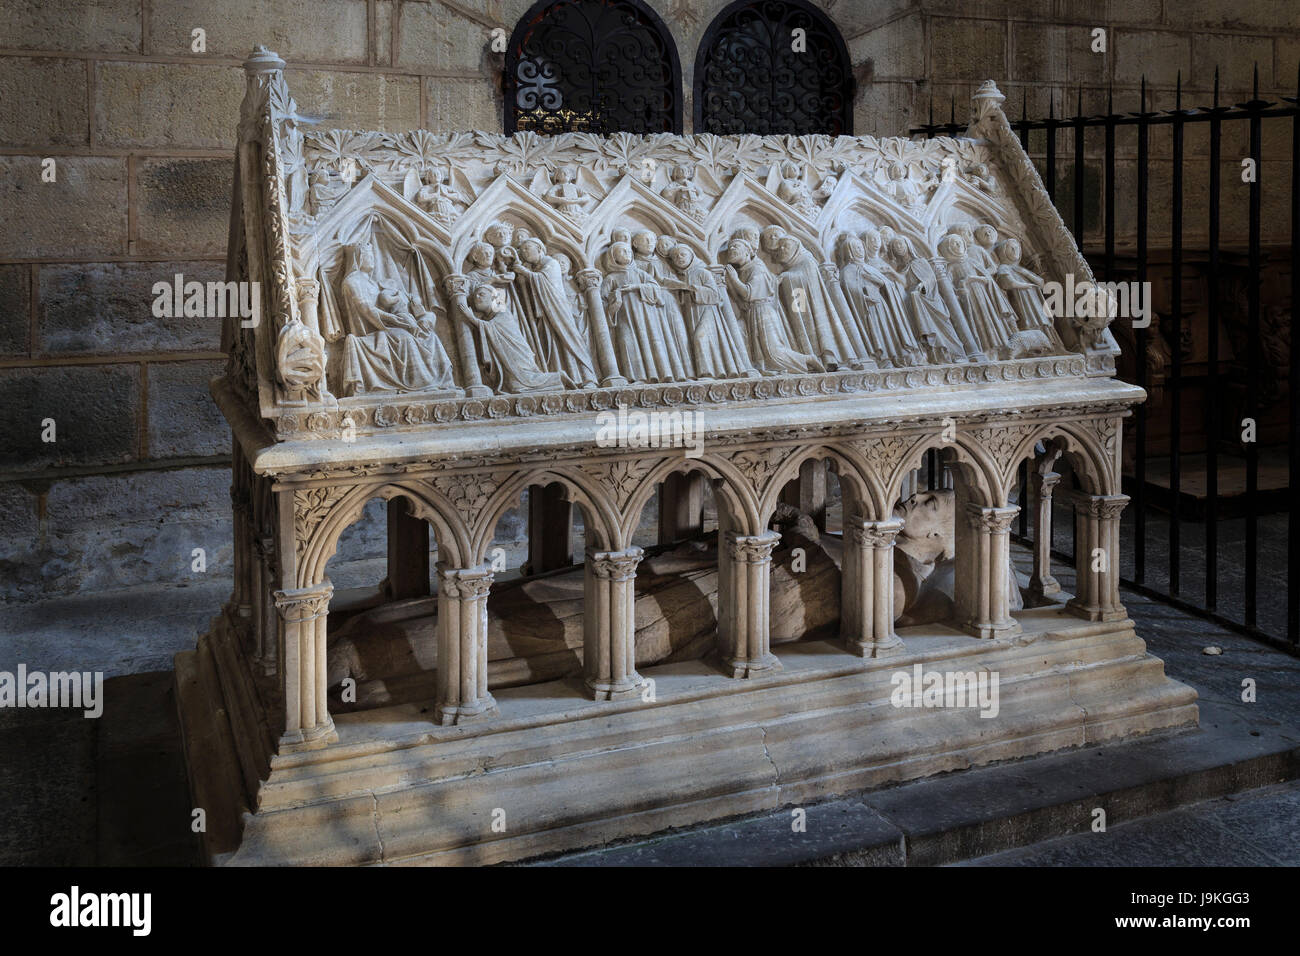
[177,49,1197,864]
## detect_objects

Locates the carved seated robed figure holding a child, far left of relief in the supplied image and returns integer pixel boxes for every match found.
[341,243,456,395]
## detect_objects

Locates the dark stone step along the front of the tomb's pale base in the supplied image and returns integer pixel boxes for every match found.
[524,700,1300,866]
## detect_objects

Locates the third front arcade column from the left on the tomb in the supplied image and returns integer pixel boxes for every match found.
[582,548,645,700]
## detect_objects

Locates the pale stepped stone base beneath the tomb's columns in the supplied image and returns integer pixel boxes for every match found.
[177,607,1197,865]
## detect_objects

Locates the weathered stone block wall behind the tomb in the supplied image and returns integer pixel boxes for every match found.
[0,0,1300,601]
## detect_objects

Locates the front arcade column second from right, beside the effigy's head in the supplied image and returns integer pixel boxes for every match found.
[957,503,1021,637]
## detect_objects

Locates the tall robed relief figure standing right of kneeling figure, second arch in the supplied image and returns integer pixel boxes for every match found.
[515,238,595,388]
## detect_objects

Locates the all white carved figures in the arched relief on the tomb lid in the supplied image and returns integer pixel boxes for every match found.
[325,212,1063,395]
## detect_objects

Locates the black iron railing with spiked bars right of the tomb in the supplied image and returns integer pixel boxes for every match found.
[913,69,1300,653]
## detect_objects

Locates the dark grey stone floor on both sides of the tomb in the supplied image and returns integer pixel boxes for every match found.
[0,554,1300,865]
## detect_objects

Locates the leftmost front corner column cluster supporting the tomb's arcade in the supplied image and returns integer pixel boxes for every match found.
[276,580,338,745]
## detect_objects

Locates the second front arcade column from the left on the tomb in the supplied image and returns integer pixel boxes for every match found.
[433,562,501,726]
